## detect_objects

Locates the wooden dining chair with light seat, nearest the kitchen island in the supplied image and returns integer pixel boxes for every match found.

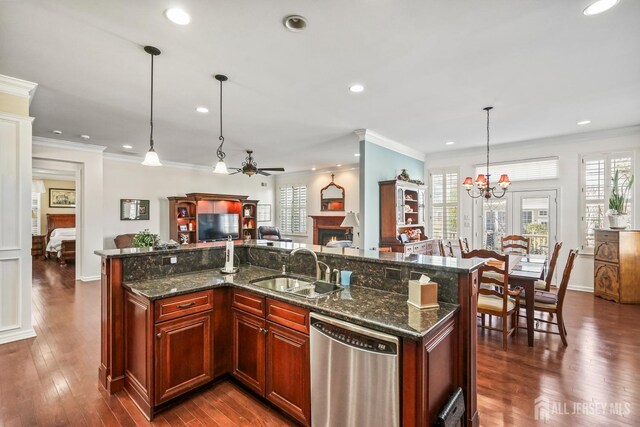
[462,249,520,351]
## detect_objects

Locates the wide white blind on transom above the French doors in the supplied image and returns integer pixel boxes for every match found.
[476,157,558,184]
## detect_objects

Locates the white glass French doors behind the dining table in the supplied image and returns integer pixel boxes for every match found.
[474,189,558,255]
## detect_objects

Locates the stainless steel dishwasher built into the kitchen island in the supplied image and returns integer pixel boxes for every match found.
[310,313,400,427]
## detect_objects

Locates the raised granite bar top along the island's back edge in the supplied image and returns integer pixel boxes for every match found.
[94,240,483,273]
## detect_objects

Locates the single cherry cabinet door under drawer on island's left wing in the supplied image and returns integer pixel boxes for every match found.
[155,311,213,405]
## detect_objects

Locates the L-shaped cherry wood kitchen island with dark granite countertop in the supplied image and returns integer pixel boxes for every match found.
[96,241,479,426]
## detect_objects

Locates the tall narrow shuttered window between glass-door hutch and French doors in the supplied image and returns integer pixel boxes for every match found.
[429,169,460,239]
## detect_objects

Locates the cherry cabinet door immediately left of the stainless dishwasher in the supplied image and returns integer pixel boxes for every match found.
[266,322,311,425]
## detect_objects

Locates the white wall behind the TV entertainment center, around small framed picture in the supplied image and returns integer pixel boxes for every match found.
[102,155,275,248]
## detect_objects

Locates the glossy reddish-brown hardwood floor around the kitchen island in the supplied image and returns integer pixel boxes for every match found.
[0,261,640,427]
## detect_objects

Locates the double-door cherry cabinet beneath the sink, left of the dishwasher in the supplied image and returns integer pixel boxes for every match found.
[232,289,311,425]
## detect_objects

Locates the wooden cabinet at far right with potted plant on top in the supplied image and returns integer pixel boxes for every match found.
[593,229,640,304]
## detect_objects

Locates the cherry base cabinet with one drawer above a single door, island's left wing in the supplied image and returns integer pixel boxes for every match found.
[124,290,214,420]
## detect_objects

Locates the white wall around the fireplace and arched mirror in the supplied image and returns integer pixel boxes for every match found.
[274,166,362,247]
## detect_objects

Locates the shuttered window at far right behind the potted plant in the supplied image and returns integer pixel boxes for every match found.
[580,153,633,252]
